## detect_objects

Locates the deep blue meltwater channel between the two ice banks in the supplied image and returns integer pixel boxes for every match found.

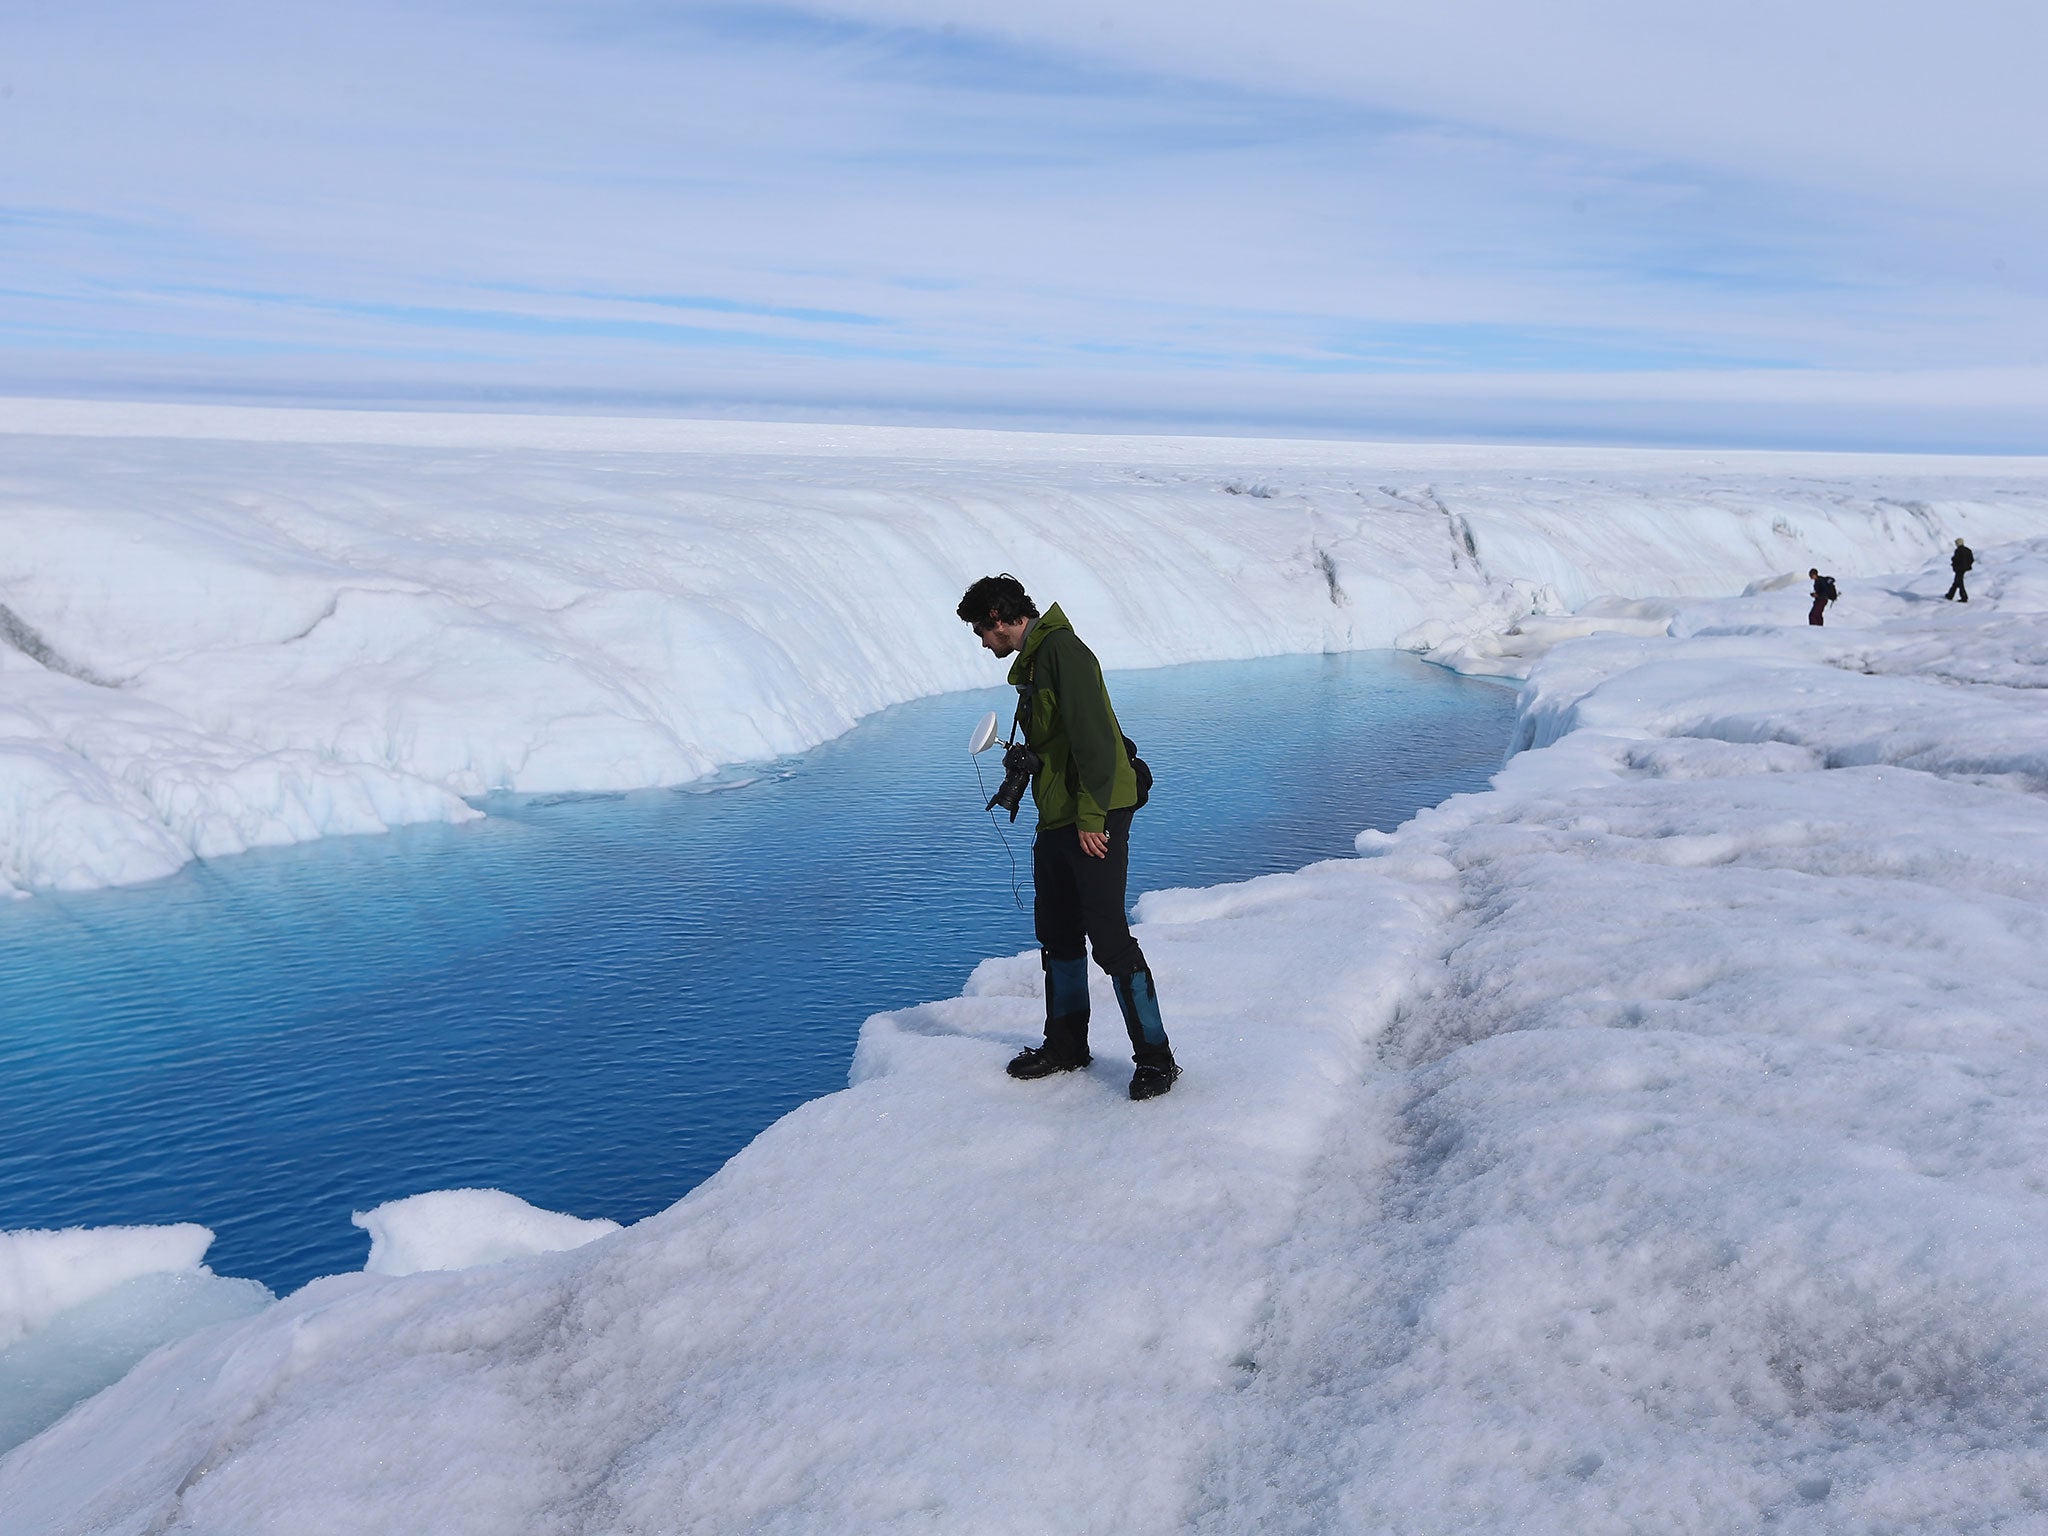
[0,653,1513,1290]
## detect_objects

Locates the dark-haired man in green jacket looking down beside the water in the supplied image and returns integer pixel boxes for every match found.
[958,575,1180,1100]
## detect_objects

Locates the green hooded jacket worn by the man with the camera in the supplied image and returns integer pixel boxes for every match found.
[1010,602,1139,831]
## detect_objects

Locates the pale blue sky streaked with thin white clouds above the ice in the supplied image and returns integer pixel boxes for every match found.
[0,0,2048,453]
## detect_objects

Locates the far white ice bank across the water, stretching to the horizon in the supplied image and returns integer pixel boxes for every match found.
[12,399,2048,891]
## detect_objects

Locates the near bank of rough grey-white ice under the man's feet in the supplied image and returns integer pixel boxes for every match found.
[12,541,2048,1536]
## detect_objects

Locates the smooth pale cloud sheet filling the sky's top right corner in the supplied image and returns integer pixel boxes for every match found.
[798,0,2048,219]
